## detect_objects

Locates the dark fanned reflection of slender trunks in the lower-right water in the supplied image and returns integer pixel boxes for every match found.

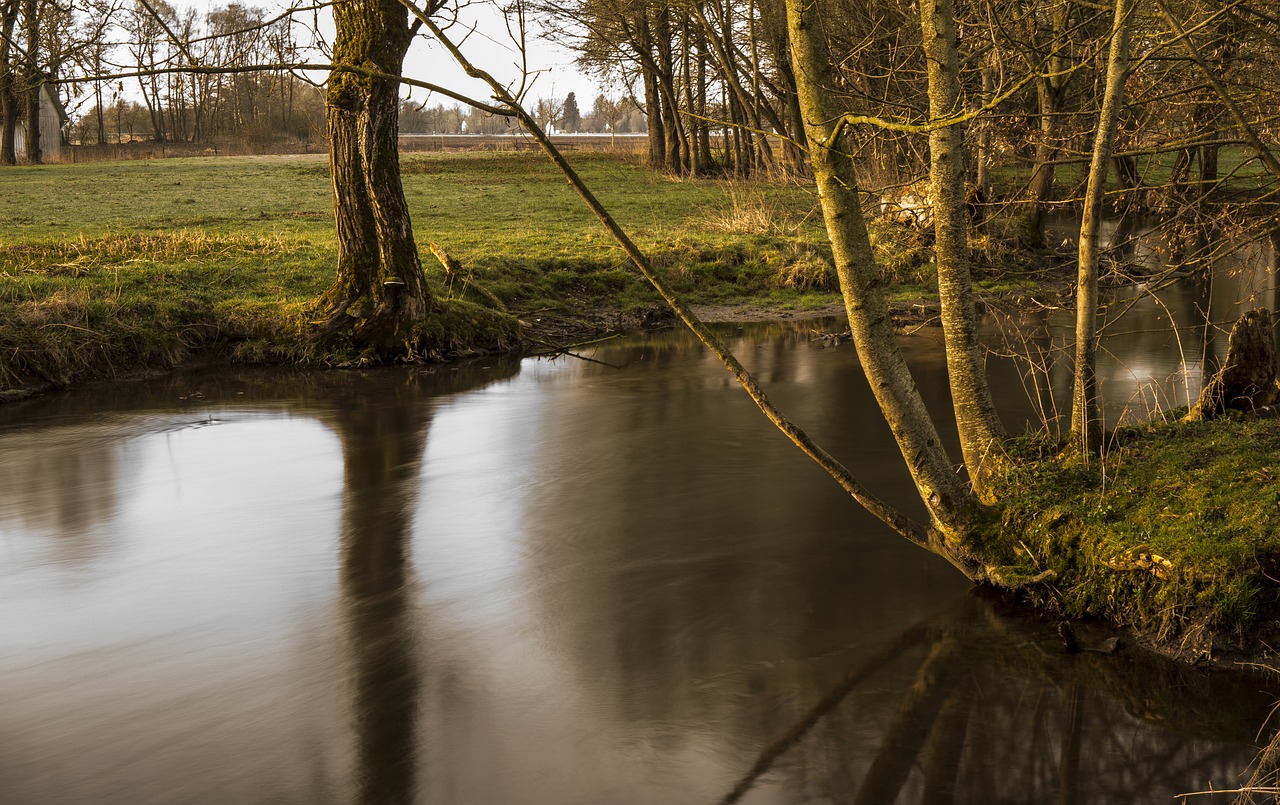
[721,596,1277,805]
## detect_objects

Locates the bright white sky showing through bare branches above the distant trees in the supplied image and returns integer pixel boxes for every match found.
[170,0,600,109]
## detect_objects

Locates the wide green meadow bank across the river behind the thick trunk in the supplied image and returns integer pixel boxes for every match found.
[0,152,1039,392]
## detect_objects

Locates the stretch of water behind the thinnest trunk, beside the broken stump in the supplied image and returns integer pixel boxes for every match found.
[988,209,1280,427]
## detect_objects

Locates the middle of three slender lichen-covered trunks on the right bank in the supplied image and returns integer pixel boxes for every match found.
[920,0,1005,497]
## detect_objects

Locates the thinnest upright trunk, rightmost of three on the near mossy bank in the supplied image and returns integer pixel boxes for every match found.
[1071,0,1134,456]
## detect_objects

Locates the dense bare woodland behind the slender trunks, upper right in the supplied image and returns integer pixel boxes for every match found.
[539,0,1280,191]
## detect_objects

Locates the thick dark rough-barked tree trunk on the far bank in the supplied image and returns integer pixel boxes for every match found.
[321,0,431,356]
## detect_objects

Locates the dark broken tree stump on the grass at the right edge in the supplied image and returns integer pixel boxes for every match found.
[1185,308,1280,422]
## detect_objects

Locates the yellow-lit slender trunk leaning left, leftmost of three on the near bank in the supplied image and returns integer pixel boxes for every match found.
[787,0,979,557]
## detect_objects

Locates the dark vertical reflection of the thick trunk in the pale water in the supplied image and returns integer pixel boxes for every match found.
[323,361,518,805]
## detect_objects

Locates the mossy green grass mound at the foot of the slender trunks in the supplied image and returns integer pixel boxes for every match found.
[983,417,1280,654]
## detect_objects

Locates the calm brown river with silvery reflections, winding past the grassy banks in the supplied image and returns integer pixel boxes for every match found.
[0,222,1275,805]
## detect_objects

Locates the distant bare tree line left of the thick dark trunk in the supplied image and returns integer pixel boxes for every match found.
[0,0,324,164]
